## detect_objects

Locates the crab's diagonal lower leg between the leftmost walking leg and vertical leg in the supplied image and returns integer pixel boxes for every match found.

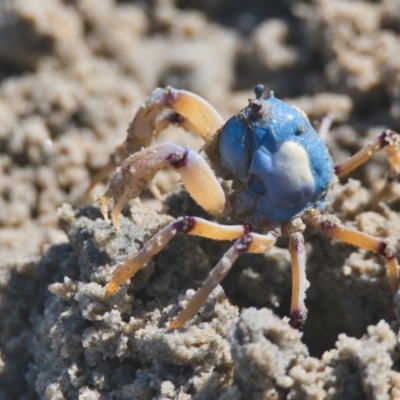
[166,231,277,330]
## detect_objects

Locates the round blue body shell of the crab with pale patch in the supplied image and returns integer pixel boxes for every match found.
[219,88,334,226]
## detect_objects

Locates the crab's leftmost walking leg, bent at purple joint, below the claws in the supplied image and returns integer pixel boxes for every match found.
[106,217,248,297]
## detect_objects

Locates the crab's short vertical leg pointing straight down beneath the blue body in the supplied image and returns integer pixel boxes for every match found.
[289,232,308,329]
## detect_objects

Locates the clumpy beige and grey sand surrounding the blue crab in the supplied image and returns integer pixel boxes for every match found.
[0,0,400,400]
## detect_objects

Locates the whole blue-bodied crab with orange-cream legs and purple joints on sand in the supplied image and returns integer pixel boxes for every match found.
[96,85,400,330]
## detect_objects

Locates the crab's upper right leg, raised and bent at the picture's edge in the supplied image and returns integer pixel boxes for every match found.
[335,129,400,178]
